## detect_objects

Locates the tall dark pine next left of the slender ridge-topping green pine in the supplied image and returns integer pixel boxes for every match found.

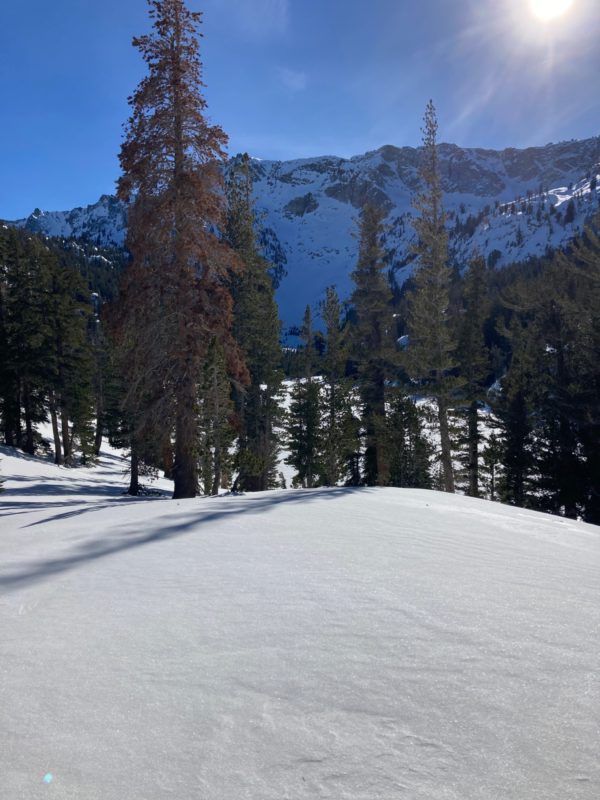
[350,205,396,486]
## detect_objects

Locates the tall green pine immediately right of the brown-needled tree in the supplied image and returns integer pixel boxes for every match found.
[226,155,283,492]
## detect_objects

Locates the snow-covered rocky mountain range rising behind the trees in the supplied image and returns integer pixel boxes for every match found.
[9,137,600,325]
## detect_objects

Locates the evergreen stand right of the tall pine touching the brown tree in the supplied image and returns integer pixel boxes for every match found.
[287,104,600,523]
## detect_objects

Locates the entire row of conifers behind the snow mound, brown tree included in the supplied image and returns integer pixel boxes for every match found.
[0,0,600,522]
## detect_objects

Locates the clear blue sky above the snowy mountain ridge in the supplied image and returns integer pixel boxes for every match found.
[0,0,600,219]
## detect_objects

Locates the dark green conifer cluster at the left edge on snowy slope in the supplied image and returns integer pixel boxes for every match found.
[0,229,95,464]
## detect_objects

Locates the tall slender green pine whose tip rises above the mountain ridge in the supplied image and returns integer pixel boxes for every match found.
[406,101,456,492]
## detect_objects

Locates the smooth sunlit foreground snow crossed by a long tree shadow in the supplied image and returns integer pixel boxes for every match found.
[0,449,600,800]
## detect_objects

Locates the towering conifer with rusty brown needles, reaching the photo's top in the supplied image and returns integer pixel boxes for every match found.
[116,0,247,498]
